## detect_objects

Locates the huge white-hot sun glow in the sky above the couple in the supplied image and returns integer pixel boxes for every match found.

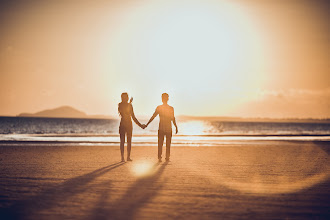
[107,1,265,115]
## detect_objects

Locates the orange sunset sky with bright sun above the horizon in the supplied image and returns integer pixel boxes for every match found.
[0,0,330,118]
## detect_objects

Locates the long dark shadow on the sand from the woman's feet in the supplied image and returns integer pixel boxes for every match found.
[0,162,125,219]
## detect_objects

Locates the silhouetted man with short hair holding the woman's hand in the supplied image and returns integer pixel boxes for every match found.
[144,93,178,162]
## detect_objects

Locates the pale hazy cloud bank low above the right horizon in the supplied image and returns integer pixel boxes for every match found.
[236,87,330,118]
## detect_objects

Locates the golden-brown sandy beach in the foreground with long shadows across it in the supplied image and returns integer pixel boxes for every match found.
[0,141,330,219]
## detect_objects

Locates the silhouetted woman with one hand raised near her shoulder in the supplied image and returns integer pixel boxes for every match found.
[118,92,143,162]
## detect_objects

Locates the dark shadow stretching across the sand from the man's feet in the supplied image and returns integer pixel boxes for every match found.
[88,163,168,219]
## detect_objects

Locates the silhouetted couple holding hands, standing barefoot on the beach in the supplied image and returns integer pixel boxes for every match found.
[118,93,178,162]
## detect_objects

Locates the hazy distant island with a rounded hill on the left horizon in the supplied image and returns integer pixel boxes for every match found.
[17,106,110,118]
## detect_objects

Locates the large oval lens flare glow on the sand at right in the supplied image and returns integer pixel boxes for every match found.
[183,145,330,195]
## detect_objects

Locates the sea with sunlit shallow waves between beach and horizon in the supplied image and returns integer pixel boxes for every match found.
[0,117,330,146]
